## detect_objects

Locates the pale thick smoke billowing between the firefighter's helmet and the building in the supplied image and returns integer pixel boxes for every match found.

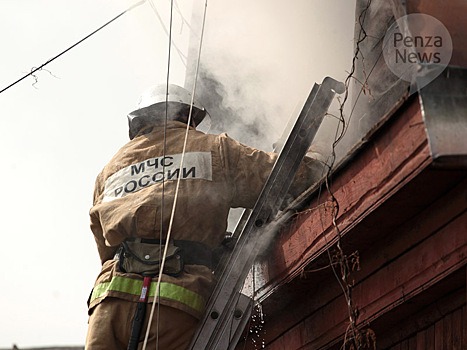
[185,0,354,151]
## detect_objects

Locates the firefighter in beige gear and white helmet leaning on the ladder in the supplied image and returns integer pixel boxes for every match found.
[86,85,322,350]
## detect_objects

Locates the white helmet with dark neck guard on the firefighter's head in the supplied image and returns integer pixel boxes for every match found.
[128,84,206,139]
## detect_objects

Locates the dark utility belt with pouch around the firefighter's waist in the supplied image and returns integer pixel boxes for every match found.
[114,238,213,276]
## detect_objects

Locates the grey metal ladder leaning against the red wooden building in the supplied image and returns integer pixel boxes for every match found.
[189,77,345,350]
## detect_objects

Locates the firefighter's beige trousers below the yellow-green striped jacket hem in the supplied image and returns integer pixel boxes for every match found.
[85,298,199,350]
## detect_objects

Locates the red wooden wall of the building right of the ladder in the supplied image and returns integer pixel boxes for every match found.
[238,98,467,350]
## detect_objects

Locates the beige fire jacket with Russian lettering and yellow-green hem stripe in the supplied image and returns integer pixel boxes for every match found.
[90,121,320,318]
